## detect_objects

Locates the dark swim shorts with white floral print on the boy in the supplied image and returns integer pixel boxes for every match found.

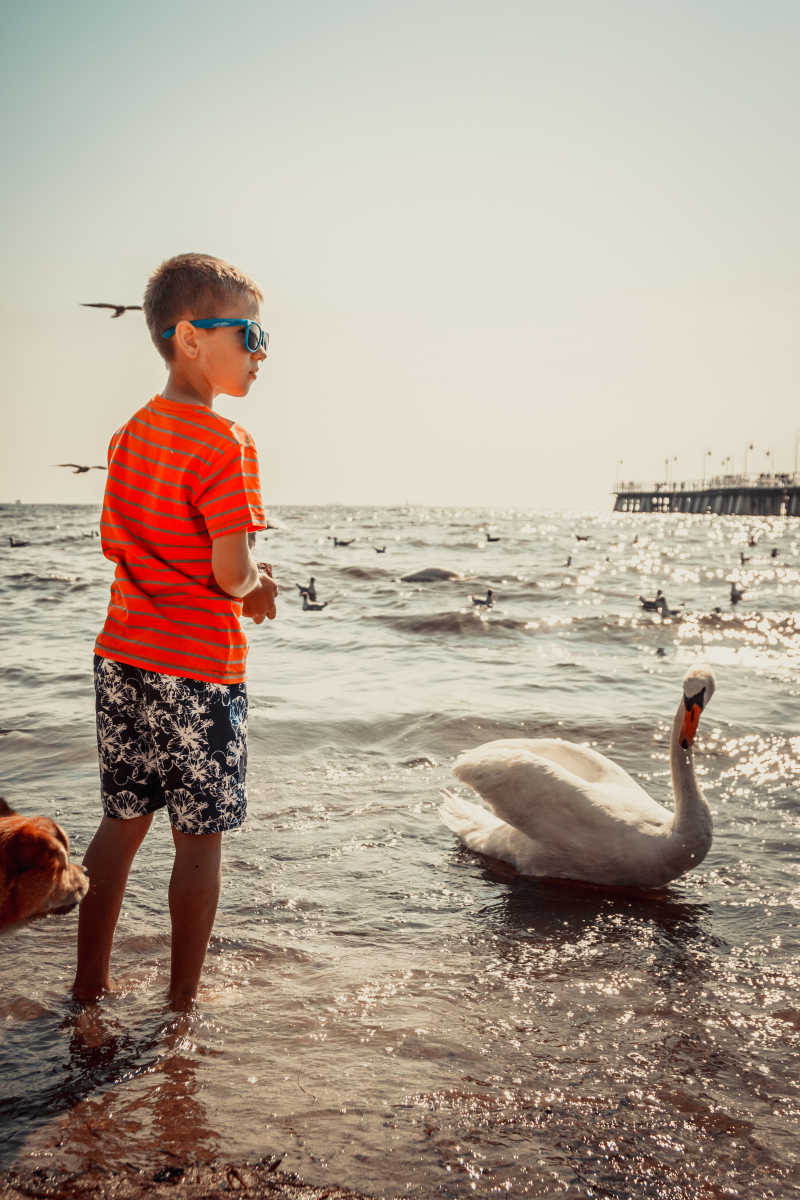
[95,654,247,834]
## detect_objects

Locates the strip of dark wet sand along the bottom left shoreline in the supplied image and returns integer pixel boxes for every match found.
[0,1158,388,1200]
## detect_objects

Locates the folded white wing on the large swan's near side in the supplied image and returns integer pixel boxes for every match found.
[453,739,673,853]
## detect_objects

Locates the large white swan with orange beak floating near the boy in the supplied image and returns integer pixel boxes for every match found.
[439,665,715,888]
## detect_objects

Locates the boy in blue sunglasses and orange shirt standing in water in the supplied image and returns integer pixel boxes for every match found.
[73,254,277,1009]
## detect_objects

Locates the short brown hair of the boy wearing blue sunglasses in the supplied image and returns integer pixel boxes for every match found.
[144,254,264,362]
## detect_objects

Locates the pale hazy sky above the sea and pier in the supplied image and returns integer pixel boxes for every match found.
[0,0,800,511]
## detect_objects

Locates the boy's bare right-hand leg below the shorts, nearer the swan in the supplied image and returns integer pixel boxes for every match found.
[169,829,222,1012]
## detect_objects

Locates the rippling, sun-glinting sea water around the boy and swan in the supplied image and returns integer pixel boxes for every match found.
[0,505,800,1200]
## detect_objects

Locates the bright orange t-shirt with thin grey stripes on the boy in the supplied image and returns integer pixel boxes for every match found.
[95,396,265,683]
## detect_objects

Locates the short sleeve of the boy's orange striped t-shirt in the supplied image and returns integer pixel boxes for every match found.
[194,438,266,538]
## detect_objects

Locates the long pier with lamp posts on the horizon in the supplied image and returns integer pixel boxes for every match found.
[613,473,800,517]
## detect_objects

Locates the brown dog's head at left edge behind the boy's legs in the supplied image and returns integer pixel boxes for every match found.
[0,799,89,931]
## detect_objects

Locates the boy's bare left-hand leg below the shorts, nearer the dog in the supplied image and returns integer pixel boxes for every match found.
[72,812,152,1002]
